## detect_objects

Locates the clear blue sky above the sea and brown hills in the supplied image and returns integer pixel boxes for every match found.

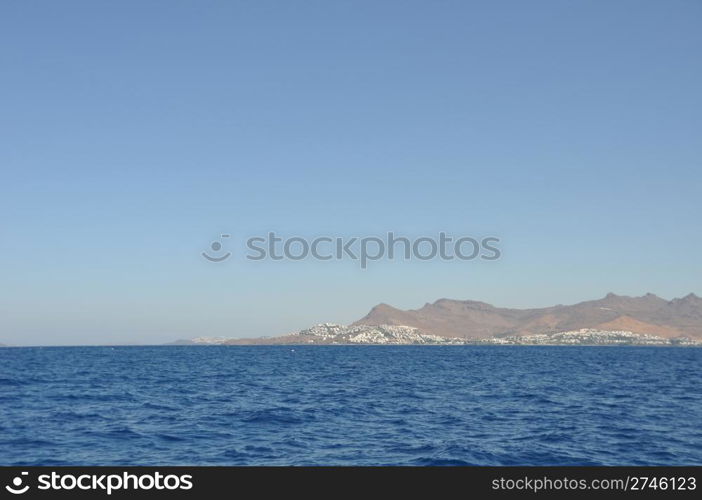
[0,0,702,344]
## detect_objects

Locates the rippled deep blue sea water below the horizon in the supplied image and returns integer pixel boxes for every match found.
[0,346,702,465]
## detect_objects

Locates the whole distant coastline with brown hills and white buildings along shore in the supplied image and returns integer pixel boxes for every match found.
[175,293,702,346]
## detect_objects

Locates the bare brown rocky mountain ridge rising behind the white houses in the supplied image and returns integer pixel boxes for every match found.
[353,293,702,339]
